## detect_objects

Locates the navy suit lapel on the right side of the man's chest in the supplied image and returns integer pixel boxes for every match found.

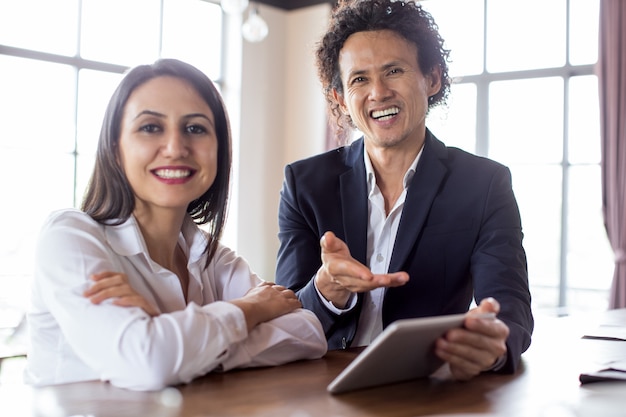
[389,131,447,272]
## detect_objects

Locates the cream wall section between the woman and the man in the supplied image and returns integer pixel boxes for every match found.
[231,4,330,280]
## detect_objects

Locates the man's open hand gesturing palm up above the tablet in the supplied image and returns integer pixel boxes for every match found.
[315,232,409,308]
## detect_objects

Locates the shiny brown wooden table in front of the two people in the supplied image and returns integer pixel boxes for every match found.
[0,310,626,417]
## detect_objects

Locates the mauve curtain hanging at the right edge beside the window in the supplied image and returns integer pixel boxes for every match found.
[598,0,626,309]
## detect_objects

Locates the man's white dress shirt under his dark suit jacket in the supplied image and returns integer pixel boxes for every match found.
[316,147,423,346]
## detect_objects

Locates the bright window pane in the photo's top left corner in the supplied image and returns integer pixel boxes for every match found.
[0,0,78,55]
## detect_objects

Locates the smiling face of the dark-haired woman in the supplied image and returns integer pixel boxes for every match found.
[119,77,221,224]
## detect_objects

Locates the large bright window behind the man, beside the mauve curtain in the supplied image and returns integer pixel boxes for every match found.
[422,0,613,311]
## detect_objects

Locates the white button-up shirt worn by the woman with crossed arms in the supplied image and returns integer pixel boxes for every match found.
[25,209,327,390]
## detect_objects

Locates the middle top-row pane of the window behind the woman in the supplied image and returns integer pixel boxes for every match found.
[80,0,161,66]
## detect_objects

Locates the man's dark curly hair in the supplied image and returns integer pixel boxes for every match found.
[316,0,451,129]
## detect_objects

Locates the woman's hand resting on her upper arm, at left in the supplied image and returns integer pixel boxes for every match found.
[83,271,159,317]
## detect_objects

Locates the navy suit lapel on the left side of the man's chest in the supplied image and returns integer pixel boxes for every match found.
[339,139,368,265]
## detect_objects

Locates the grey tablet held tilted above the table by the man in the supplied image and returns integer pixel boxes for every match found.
[326,314,494,394]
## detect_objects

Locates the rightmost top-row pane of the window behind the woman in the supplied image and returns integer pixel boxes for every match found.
[161,0,222,80]
